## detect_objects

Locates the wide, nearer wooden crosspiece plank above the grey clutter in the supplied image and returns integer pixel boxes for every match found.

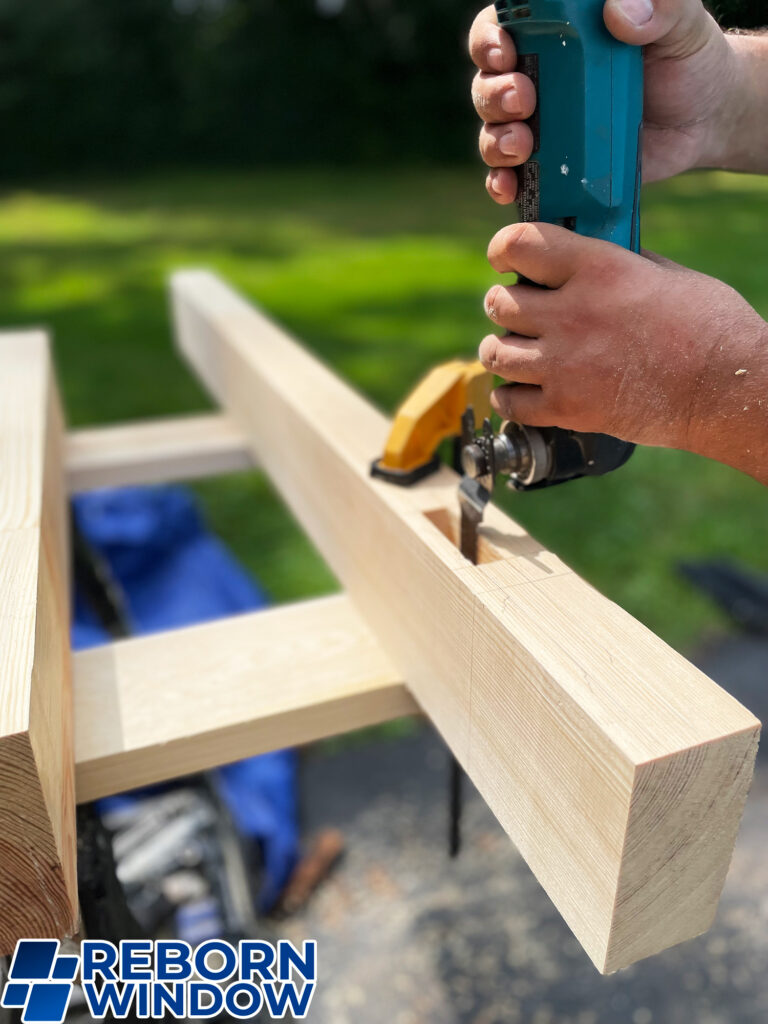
[75,597,418,803]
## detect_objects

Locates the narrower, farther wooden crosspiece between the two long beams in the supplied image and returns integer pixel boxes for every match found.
[67,414,253,494]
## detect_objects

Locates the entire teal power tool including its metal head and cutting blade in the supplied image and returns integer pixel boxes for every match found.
[460,0,643,560]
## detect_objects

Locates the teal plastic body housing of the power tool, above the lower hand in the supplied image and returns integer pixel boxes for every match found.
[496,0,643,252]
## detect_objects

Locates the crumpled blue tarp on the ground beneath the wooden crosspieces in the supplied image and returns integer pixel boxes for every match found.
[73,487,298,909]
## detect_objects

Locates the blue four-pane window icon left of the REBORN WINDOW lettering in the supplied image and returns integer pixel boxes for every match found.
[0,939,80,1024]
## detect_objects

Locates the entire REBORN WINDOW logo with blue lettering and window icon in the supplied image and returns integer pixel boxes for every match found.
[0,939,317,1024]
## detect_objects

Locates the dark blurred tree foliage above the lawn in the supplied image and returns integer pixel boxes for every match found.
[0,0,768,177]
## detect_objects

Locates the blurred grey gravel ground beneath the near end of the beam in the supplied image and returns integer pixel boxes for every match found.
[280,640,768,1024]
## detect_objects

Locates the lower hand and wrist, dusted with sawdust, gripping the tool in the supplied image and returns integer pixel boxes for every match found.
[480,224,768,482]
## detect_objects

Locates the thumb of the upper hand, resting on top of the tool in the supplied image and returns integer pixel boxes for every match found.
[603,0,716,57]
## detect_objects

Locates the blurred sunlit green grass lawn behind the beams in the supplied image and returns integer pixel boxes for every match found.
[0,168,768,647]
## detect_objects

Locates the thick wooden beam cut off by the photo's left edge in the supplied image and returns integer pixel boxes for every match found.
[0,332,77,954]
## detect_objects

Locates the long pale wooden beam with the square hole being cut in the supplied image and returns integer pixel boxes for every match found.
[172,271,759,972]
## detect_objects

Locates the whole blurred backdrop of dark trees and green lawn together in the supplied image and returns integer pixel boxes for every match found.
[0,0,768,648]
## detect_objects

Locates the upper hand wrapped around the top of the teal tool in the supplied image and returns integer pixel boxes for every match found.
[469,0,753,197]
